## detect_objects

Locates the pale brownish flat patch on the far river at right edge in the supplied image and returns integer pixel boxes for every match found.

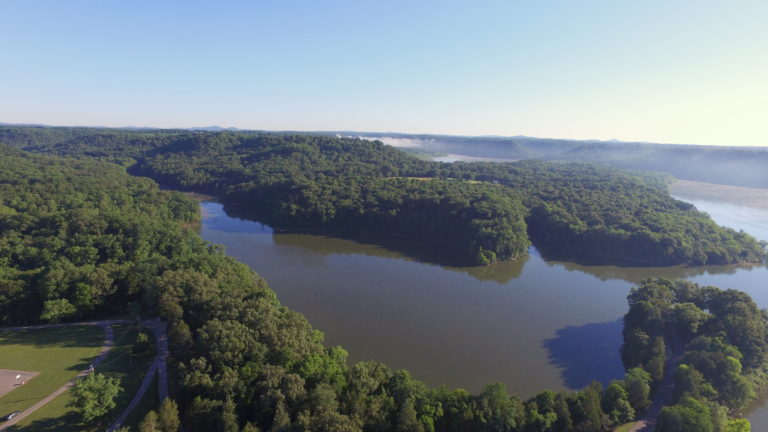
[669,180,768,211]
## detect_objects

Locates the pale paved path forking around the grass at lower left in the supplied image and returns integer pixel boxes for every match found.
[0,318,168,432]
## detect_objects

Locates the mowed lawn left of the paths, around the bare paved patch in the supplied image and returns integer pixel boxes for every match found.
[0,325,104,416]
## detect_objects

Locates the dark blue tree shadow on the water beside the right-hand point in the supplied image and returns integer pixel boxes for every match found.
[542,319,624,390]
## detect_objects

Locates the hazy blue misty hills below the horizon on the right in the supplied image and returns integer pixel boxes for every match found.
[348,133,768,188]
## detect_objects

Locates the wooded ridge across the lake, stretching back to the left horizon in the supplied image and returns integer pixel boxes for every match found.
[0,127,765,265]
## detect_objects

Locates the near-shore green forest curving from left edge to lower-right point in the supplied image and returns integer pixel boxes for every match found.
[0,146,768,432]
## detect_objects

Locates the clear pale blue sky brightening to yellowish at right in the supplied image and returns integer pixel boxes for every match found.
[0,0,768,146]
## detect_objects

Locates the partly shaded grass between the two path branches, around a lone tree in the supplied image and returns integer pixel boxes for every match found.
[9,325,157,432]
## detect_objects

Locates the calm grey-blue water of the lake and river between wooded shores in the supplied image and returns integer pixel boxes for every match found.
[200,192,768,422]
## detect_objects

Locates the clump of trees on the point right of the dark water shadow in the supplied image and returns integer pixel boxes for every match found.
[622,279,768,432]
